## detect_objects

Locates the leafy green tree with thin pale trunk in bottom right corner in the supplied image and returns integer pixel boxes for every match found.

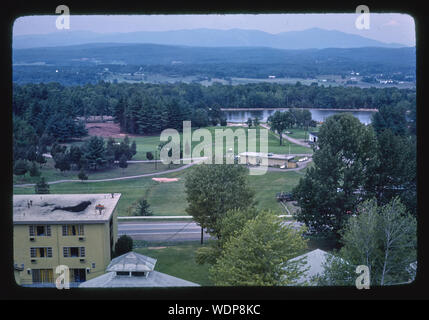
[318,198,417,285]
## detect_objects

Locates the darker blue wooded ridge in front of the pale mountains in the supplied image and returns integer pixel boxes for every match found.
[13,43,416,69]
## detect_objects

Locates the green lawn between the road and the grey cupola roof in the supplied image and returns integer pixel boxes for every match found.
[134,243,213,286]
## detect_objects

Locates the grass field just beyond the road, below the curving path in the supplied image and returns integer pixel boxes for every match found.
[14,169,306,216]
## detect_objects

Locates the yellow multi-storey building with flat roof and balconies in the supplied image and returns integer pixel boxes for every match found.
[13,193,121,286]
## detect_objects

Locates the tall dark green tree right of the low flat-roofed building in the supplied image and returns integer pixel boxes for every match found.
[293,114,378,237]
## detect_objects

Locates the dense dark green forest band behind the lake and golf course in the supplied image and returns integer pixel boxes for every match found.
[13,82,416,156]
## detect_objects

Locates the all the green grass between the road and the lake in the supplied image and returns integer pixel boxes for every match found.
[13,127,311,216]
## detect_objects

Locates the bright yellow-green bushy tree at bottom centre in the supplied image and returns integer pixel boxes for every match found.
[209,211,307,286]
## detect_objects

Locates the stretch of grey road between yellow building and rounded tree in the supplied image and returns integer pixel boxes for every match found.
[118,221,210,242]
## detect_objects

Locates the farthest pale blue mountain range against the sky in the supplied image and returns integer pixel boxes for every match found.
[12,28,405,49]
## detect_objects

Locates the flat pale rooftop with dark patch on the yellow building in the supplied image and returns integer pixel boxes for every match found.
[13,193,121,224]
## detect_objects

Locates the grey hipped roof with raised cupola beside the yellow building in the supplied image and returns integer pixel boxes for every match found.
[79,251,199,288]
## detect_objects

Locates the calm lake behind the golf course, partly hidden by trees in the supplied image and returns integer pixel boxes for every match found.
[223,109,374,124]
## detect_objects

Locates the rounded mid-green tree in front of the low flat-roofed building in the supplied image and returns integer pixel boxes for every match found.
[185,164,254,242]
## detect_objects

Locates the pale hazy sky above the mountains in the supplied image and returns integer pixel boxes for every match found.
[13,12,416,46]
